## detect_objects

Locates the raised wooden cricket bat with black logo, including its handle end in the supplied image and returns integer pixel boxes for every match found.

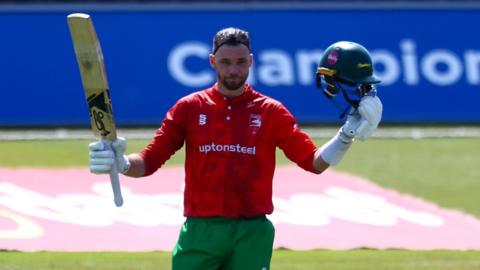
[67,13,123,207]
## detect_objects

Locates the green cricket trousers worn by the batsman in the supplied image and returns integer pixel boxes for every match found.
[172,216,275,270]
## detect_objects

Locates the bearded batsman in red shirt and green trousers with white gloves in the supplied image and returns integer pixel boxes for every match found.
[89,28,382,270]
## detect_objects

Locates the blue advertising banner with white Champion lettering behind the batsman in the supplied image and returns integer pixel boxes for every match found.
[0,6,480,127]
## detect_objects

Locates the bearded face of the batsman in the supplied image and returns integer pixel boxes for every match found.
[210,44,252,91]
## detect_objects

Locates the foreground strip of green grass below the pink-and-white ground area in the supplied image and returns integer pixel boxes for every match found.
[0,249,480,270]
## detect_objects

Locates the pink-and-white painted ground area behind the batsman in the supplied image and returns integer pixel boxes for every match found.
[0,167,480,251]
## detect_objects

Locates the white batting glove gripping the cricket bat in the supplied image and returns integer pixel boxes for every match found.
[88,137,130,174]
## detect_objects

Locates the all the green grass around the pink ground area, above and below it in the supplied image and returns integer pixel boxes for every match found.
[0,138,480,270]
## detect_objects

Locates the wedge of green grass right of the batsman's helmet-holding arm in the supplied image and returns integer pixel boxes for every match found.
[336,138,480,217]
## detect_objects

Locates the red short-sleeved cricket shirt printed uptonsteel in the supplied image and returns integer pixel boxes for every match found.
[140,85,317,218]
